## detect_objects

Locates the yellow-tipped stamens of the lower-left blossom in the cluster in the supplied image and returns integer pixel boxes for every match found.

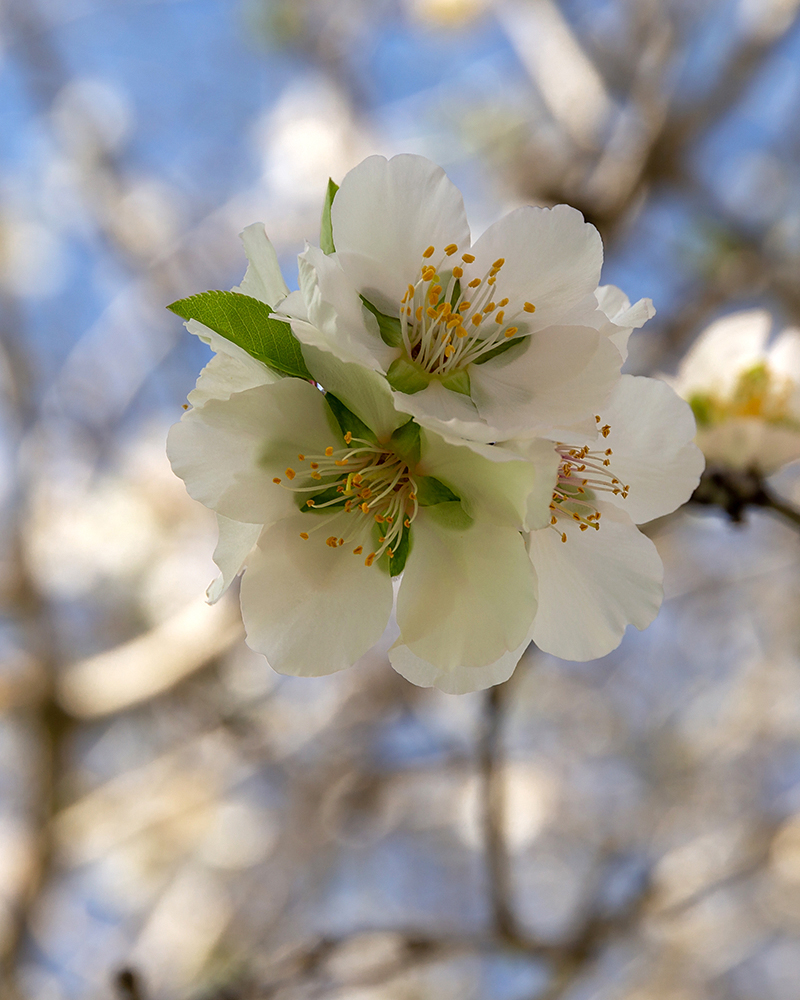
[272,431,418,566]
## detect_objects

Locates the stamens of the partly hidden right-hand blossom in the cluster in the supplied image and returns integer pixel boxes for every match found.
[550,416,630,542]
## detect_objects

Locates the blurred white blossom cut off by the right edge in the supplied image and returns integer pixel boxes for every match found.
[674,309,800,475]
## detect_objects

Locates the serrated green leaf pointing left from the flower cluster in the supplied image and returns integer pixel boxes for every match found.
[167,291,311,381]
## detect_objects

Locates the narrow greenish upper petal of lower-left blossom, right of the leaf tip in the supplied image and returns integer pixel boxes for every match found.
[302,345,408,442]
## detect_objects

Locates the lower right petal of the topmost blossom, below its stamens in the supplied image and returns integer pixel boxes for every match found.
[470,326,621,440]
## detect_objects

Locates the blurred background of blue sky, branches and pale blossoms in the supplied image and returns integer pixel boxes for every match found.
[0,0,800,1000]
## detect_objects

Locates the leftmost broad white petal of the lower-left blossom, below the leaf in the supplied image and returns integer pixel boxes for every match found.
[167,378,342,524]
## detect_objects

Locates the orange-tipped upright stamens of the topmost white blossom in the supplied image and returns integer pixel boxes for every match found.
[400,243,536,375]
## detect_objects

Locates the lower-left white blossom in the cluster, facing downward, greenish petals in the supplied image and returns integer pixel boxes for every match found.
[168,344,557,692]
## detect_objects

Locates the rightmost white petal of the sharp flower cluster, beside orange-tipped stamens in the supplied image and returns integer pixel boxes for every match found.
[599,375,705,524]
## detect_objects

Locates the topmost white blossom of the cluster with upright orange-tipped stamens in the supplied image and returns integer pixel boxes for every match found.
[281,155,653,442]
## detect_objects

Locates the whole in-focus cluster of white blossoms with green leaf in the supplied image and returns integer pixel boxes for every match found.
[169,156,703,693]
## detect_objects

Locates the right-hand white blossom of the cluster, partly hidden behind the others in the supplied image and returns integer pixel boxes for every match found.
[528,375,703,660]
